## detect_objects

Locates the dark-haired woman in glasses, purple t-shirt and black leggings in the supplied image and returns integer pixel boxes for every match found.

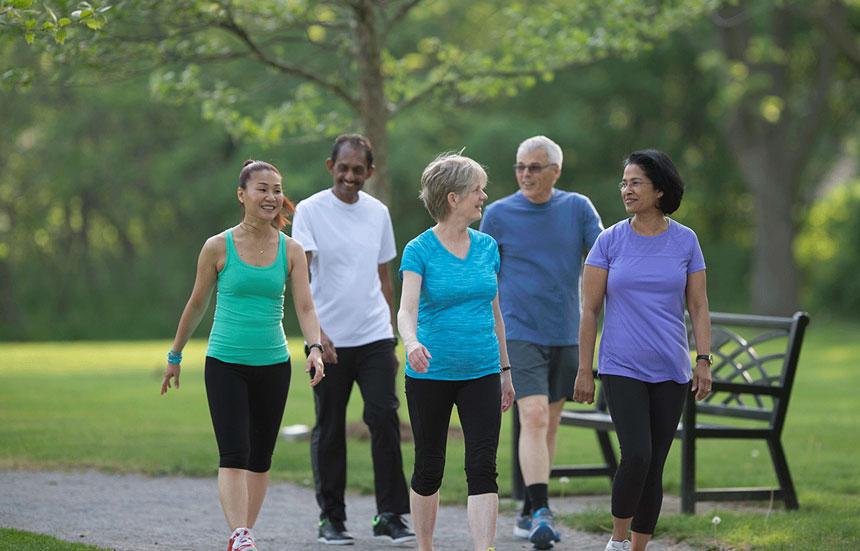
[573,149,711,551]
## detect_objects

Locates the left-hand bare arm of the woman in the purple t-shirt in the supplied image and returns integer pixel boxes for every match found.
[573,264,609,404]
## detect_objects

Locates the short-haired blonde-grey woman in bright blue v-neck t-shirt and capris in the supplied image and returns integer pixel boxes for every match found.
[397,155,514,551]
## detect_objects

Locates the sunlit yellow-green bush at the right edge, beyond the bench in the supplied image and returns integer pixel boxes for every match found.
[795,180,860,318]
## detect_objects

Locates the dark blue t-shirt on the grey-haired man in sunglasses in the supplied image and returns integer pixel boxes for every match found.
[481,189,603,346]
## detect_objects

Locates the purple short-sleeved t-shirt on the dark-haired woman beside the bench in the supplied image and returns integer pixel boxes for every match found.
[585,220,705,383]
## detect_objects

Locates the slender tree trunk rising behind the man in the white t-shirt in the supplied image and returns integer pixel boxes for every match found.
[353,0,390,204]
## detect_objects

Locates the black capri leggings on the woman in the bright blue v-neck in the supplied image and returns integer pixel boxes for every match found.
[406,373,502,496]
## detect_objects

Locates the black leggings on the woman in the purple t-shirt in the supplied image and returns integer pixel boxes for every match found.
[600,375,690,534]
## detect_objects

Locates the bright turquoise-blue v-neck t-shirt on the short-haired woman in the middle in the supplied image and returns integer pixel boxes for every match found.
[400,228,500,381]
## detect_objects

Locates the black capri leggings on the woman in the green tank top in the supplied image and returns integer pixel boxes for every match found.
[205,356,291,473]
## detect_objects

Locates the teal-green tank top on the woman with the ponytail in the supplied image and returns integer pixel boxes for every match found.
[206,229,290,365]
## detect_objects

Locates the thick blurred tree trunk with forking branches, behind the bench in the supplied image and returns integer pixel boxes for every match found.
[719,4,834,315]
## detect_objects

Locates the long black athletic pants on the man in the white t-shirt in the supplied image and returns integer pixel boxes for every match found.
[311,339,409,521]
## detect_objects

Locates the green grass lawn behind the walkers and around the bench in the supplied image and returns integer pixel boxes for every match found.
[0,320,860,549]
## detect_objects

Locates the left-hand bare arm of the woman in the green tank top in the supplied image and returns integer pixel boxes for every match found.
[161,239,226,394]
